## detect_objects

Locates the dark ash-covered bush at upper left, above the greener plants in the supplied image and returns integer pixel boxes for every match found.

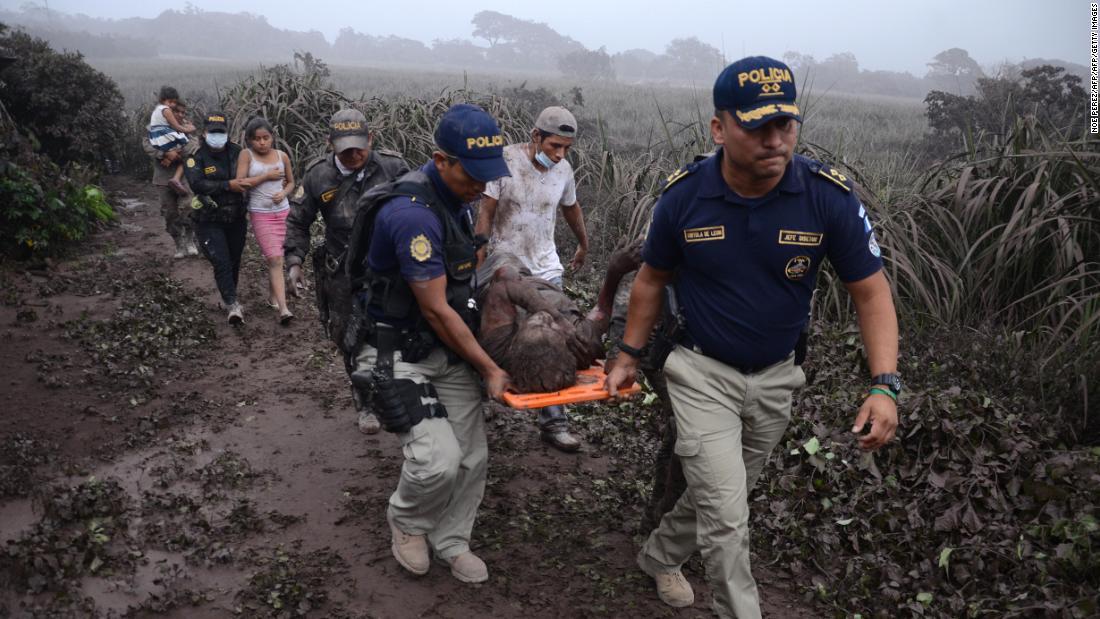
[0,24,125,168]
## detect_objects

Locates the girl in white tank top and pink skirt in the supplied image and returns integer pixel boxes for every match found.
[237,117,294,325]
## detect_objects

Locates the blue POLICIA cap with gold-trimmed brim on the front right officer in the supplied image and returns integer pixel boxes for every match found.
[714,56,802,129]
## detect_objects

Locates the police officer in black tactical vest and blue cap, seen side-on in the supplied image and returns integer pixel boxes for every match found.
[349,103,508,583]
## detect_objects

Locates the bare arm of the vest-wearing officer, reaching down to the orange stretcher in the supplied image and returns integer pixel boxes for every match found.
[409,275,509,400]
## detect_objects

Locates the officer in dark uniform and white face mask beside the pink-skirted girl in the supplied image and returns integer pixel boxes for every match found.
[184,112,249,324]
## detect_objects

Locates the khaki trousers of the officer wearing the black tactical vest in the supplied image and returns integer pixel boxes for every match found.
[355,346,488,559]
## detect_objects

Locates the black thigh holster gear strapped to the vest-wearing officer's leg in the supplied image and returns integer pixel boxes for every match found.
[351,324,447,433]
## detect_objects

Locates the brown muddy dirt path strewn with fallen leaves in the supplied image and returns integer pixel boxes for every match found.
[0,178,821,618]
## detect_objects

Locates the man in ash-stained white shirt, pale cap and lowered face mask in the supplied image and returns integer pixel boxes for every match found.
[476,107,589,452]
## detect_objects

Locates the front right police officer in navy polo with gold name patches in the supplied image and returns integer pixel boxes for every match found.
[607,56,901,619]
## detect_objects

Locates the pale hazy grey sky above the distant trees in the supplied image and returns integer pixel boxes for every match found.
[8,0,1089,76]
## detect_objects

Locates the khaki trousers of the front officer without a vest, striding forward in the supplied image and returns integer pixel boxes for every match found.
[642,346,805,619]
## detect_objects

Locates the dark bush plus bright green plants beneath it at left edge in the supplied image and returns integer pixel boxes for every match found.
[0,24,123,258]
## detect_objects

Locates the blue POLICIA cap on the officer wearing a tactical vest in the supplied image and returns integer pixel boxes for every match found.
[436,103,512,183]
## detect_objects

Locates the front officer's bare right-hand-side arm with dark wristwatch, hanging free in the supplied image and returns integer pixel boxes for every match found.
[846,270,898,450]
